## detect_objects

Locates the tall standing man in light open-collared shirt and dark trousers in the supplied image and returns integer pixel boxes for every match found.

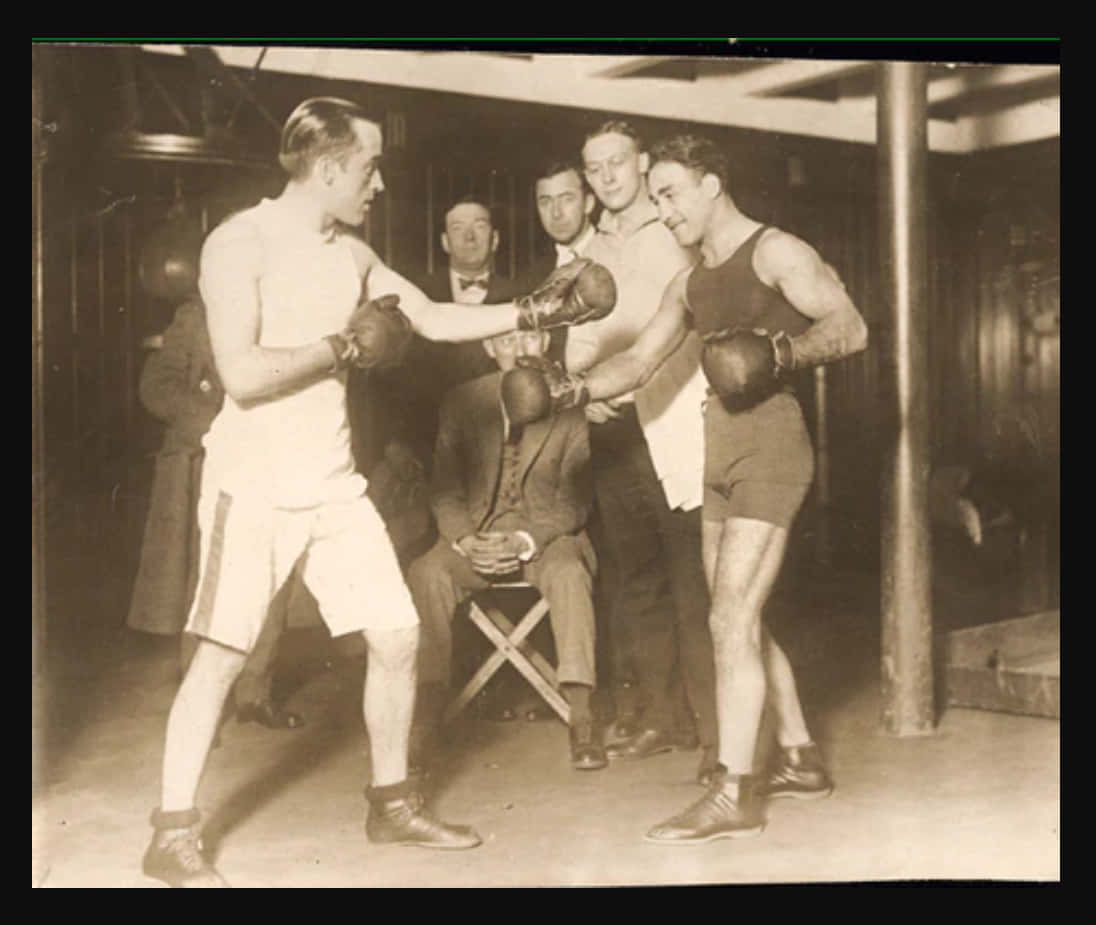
[564,122,717,779]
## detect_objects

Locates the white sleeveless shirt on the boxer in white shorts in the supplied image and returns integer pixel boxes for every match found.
[203,199,366,509]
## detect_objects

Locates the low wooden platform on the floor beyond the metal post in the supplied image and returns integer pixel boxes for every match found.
[943,610,1061,719]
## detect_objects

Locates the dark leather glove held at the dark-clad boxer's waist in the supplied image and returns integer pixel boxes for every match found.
[700,329,795,411]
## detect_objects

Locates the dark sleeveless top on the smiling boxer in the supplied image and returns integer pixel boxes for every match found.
[685,226,811,336]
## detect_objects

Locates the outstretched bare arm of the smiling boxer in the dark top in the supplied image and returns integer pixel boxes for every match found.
[585,265,688,401]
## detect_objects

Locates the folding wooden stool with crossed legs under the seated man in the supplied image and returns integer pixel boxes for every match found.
[443,581,571,726]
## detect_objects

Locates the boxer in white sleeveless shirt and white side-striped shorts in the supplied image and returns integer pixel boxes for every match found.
[142,99,556,887]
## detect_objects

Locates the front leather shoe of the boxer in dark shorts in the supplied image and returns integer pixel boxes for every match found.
[644,765,765,845]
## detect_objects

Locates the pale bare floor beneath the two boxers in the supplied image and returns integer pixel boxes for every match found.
[32,569,1060,888]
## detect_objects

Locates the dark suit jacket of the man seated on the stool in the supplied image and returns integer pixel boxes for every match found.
[431,370,593,555]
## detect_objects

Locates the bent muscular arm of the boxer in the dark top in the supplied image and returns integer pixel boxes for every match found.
[754,231,868,368]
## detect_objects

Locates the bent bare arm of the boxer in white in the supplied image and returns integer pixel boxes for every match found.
[199,222,335,402]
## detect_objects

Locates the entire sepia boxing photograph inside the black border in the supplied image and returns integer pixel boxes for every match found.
[31,37,1061,889]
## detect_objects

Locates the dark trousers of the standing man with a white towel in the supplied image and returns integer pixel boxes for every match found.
[590,406,717,745]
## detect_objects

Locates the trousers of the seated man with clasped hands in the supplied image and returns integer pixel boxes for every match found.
[408,535,596,687]
